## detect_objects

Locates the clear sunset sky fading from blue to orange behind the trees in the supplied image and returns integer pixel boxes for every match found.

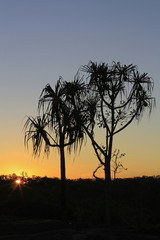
[0,0,160,178]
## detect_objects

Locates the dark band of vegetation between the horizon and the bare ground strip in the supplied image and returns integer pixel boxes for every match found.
[0,174,160,227]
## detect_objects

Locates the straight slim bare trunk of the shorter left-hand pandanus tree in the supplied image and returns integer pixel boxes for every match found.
[60,146,66,219]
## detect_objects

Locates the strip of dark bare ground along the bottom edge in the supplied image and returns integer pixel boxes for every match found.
[0,216,160,240]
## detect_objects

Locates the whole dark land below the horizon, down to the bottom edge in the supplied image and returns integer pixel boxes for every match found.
[0,177,160,240]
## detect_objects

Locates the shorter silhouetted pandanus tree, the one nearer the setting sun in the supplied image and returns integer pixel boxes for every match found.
[24,78,83,217]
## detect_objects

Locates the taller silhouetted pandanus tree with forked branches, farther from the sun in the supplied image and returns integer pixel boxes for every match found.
[81,62,155,225]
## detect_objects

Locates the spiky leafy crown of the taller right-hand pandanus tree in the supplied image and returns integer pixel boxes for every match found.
[81,62,155,137]
